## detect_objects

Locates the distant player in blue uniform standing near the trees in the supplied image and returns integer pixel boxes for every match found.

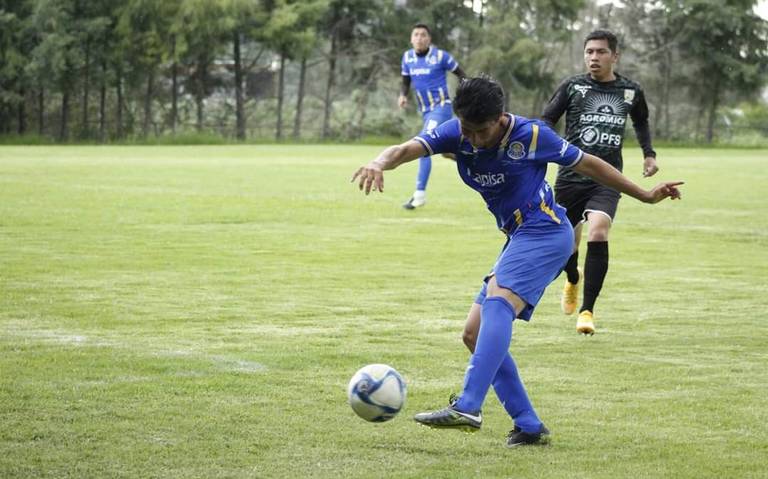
[397,23,466,210]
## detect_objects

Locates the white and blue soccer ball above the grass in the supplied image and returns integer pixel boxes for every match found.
[347,364,405,422]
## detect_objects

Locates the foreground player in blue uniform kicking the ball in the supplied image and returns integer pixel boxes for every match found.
[352,78,682,447]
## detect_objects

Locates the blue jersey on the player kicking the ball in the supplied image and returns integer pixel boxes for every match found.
[414,113,583,234]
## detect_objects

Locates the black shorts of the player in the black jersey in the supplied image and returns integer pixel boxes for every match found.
[555,180,621,227]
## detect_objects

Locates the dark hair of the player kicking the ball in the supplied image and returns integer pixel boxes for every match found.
[453,75,504,124]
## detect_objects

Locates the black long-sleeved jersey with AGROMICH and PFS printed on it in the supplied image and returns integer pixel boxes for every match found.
[541,74,656,182]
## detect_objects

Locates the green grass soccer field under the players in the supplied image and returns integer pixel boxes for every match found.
[0,146,768,479]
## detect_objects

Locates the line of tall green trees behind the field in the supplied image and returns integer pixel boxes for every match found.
[0,0,768,141]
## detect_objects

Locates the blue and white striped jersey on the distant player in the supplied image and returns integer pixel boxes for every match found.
[400,46,459,112]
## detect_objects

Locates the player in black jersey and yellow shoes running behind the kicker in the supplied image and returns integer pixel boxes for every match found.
[542,30,659,334]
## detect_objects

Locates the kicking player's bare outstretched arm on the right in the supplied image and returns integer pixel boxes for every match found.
[573,153,683,203]
